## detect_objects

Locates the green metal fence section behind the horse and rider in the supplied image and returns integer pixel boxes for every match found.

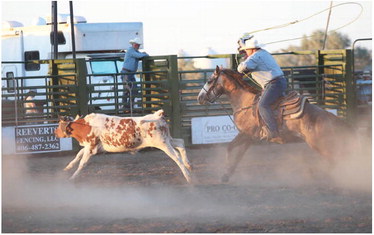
[173,50,356,144]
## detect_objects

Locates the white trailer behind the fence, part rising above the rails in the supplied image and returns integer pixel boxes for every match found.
[1,14,143,81]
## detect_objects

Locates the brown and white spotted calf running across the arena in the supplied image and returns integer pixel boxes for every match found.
[55,110,191,182]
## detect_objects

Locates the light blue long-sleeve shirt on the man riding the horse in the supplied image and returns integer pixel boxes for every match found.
[238,49,283,88]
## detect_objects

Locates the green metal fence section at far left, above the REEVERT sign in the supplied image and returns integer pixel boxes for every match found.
[2,60,84,126]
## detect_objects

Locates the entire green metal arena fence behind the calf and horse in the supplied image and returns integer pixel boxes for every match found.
[2,50,356,147]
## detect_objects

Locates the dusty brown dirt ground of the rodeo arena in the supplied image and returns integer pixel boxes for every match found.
[2,141,372,233]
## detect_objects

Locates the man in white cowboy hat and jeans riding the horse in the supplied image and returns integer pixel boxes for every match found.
[238,35,287,141]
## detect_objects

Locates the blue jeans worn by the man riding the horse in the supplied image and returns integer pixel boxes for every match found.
[258,77,287,133]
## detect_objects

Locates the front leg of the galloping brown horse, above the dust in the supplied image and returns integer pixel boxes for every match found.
[221,133,250,183]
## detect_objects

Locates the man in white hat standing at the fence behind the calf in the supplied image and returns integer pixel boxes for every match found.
[121,38,148,109]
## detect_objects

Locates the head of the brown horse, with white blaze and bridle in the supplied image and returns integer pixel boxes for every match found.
[197,66,225,104]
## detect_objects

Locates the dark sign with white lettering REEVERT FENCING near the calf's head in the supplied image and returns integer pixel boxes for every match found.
[14,125,61,153]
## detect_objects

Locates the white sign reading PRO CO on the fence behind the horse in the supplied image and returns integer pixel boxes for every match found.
[191,116,239,144]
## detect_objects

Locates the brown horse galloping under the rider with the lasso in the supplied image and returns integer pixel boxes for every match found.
[198,66,354,182]
